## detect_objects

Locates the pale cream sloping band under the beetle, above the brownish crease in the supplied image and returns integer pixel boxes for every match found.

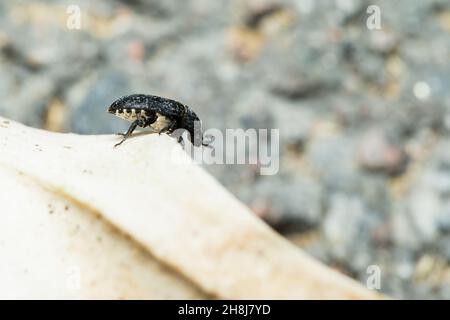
[0,118,381,299]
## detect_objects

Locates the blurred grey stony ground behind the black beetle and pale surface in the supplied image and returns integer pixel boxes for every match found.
[0,0,450,299]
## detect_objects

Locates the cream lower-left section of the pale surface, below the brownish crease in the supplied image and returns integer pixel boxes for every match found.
[0,167,208,299]
